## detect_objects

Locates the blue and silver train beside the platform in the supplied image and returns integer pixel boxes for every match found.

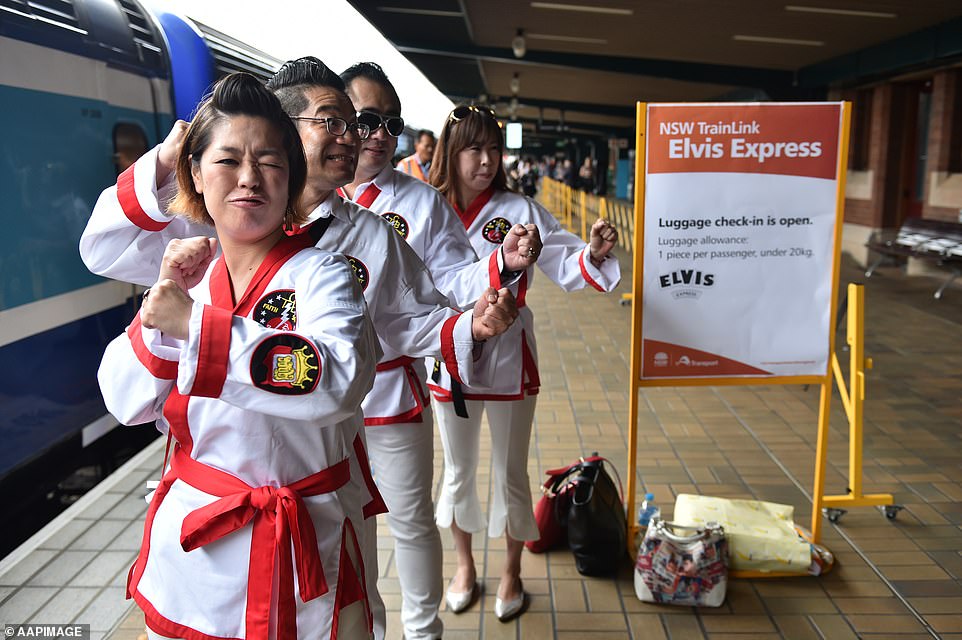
[0,0,280,556]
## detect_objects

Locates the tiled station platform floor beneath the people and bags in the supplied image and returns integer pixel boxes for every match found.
[0,254,962,640]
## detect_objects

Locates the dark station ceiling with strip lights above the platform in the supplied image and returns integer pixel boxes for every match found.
[349,0,962,145]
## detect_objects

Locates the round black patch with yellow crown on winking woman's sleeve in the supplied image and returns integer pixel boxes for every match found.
[251,333,321,396]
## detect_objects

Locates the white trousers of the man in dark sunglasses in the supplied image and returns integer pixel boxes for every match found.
[366,407,444,640]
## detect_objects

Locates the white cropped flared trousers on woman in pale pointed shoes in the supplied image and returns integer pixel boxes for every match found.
[431,396,539,540]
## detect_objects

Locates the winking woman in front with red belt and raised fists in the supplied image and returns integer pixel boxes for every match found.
[98,74,381,640]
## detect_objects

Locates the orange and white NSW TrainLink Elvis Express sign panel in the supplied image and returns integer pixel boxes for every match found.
[641,103,843,379]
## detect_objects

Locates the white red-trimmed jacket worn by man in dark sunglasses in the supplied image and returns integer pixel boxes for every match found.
[338,165,517,425]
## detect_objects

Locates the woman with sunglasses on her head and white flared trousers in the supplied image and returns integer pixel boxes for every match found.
[429,105,621,622]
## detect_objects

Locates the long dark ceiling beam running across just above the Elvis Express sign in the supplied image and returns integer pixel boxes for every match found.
[392,40,794,88]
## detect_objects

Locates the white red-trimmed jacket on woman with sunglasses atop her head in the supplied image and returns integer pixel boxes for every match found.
[428,189,621,402]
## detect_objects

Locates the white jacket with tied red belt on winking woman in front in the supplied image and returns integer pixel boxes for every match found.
[98,236,383,640]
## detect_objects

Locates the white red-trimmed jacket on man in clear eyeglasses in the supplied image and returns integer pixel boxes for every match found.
[80,147,480,424]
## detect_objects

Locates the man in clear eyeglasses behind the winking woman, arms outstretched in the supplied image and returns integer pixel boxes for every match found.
[80,57,517,639]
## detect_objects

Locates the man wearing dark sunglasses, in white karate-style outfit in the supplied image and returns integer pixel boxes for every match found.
[341,62,541,640]
